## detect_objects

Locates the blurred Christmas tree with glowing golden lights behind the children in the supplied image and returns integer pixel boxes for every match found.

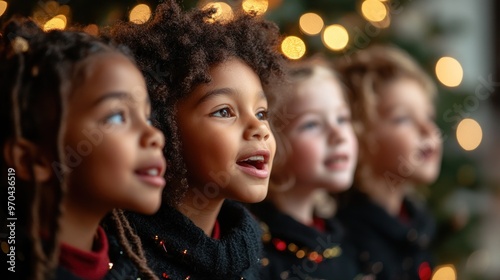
[1,0,500,279]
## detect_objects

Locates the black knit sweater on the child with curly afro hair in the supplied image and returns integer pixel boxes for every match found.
[127,200,262,280]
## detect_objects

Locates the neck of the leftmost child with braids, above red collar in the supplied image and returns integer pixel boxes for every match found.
[59,205,105,252]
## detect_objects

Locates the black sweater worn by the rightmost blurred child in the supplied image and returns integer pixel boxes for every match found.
[338,192,435,280]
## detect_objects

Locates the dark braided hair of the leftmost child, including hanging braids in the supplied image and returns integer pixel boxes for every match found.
[0,18,156,279]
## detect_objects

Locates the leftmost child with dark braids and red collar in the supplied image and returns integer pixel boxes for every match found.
[0,16,165,279]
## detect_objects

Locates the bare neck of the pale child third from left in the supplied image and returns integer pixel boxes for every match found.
[271,186,320,225]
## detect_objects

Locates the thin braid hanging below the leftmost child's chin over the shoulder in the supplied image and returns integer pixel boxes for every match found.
[111,209,159,280]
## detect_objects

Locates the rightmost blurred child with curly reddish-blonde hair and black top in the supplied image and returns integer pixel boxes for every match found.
[339,46,441,280]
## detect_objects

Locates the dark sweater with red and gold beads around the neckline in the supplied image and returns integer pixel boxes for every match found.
[252,202,361,280]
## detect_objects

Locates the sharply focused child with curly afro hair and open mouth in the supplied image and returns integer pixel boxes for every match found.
[109,1,283,280]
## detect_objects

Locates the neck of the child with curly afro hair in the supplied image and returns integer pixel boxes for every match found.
[177,188,224,236]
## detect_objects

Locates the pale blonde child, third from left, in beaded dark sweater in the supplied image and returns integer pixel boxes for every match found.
[252,59,364,279]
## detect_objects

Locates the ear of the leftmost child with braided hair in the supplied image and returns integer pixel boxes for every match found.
[3,139,52,183]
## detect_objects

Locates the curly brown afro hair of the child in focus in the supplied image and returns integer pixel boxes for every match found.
[106,0,284,205]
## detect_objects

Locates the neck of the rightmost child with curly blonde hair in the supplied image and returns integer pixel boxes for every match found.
[359,177,409,217]
